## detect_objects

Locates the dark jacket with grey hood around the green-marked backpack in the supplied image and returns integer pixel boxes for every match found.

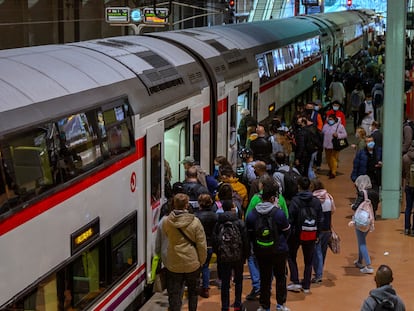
[246,202,290,252]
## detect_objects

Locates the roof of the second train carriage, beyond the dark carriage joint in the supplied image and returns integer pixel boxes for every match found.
[146,18,320,81]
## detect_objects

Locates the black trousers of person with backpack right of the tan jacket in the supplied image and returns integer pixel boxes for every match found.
[218,261,244,311]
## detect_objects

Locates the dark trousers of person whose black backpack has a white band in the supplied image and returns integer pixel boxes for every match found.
[288,237,315,289]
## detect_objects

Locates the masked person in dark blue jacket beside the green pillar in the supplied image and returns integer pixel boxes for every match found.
[351,136,382,191]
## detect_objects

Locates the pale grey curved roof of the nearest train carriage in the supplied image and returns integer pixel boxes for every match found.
[0,36,207,134]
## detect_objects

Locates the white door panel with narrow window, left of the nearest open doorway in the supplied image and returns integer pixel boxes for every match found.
[145,121,164,277]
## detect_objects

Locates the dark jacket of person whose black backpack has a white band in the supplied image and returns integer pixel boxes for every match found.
[289,190,323,239]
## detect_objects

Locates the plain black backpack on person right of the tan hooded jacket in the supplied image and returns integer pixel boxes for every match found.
[216,220,243,262]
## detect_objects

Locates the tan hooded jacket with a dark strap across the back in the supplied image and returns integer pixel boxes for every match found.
[162,210,207,273]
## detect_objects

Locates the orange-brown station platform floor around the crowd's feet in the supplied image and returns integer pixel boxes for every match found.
[140,120,414,311]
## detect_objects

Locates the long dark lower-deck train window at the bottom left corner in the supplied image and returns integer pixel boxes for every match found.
[2,213,137,311]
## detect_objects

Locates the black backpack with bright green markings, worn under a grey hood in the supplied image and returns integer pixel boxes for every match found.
[253,207,279,255]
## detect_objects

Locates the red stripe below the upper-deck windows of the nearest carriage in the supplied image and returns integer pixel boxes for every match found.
[0,137,145,236]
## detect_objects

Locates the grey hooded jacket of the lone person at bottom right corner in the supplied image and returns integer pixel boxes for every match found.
[361,285,405,311]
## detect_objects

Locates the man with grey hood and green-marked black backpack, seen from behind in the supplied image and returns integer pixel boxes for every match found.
[246,180,290,311]
